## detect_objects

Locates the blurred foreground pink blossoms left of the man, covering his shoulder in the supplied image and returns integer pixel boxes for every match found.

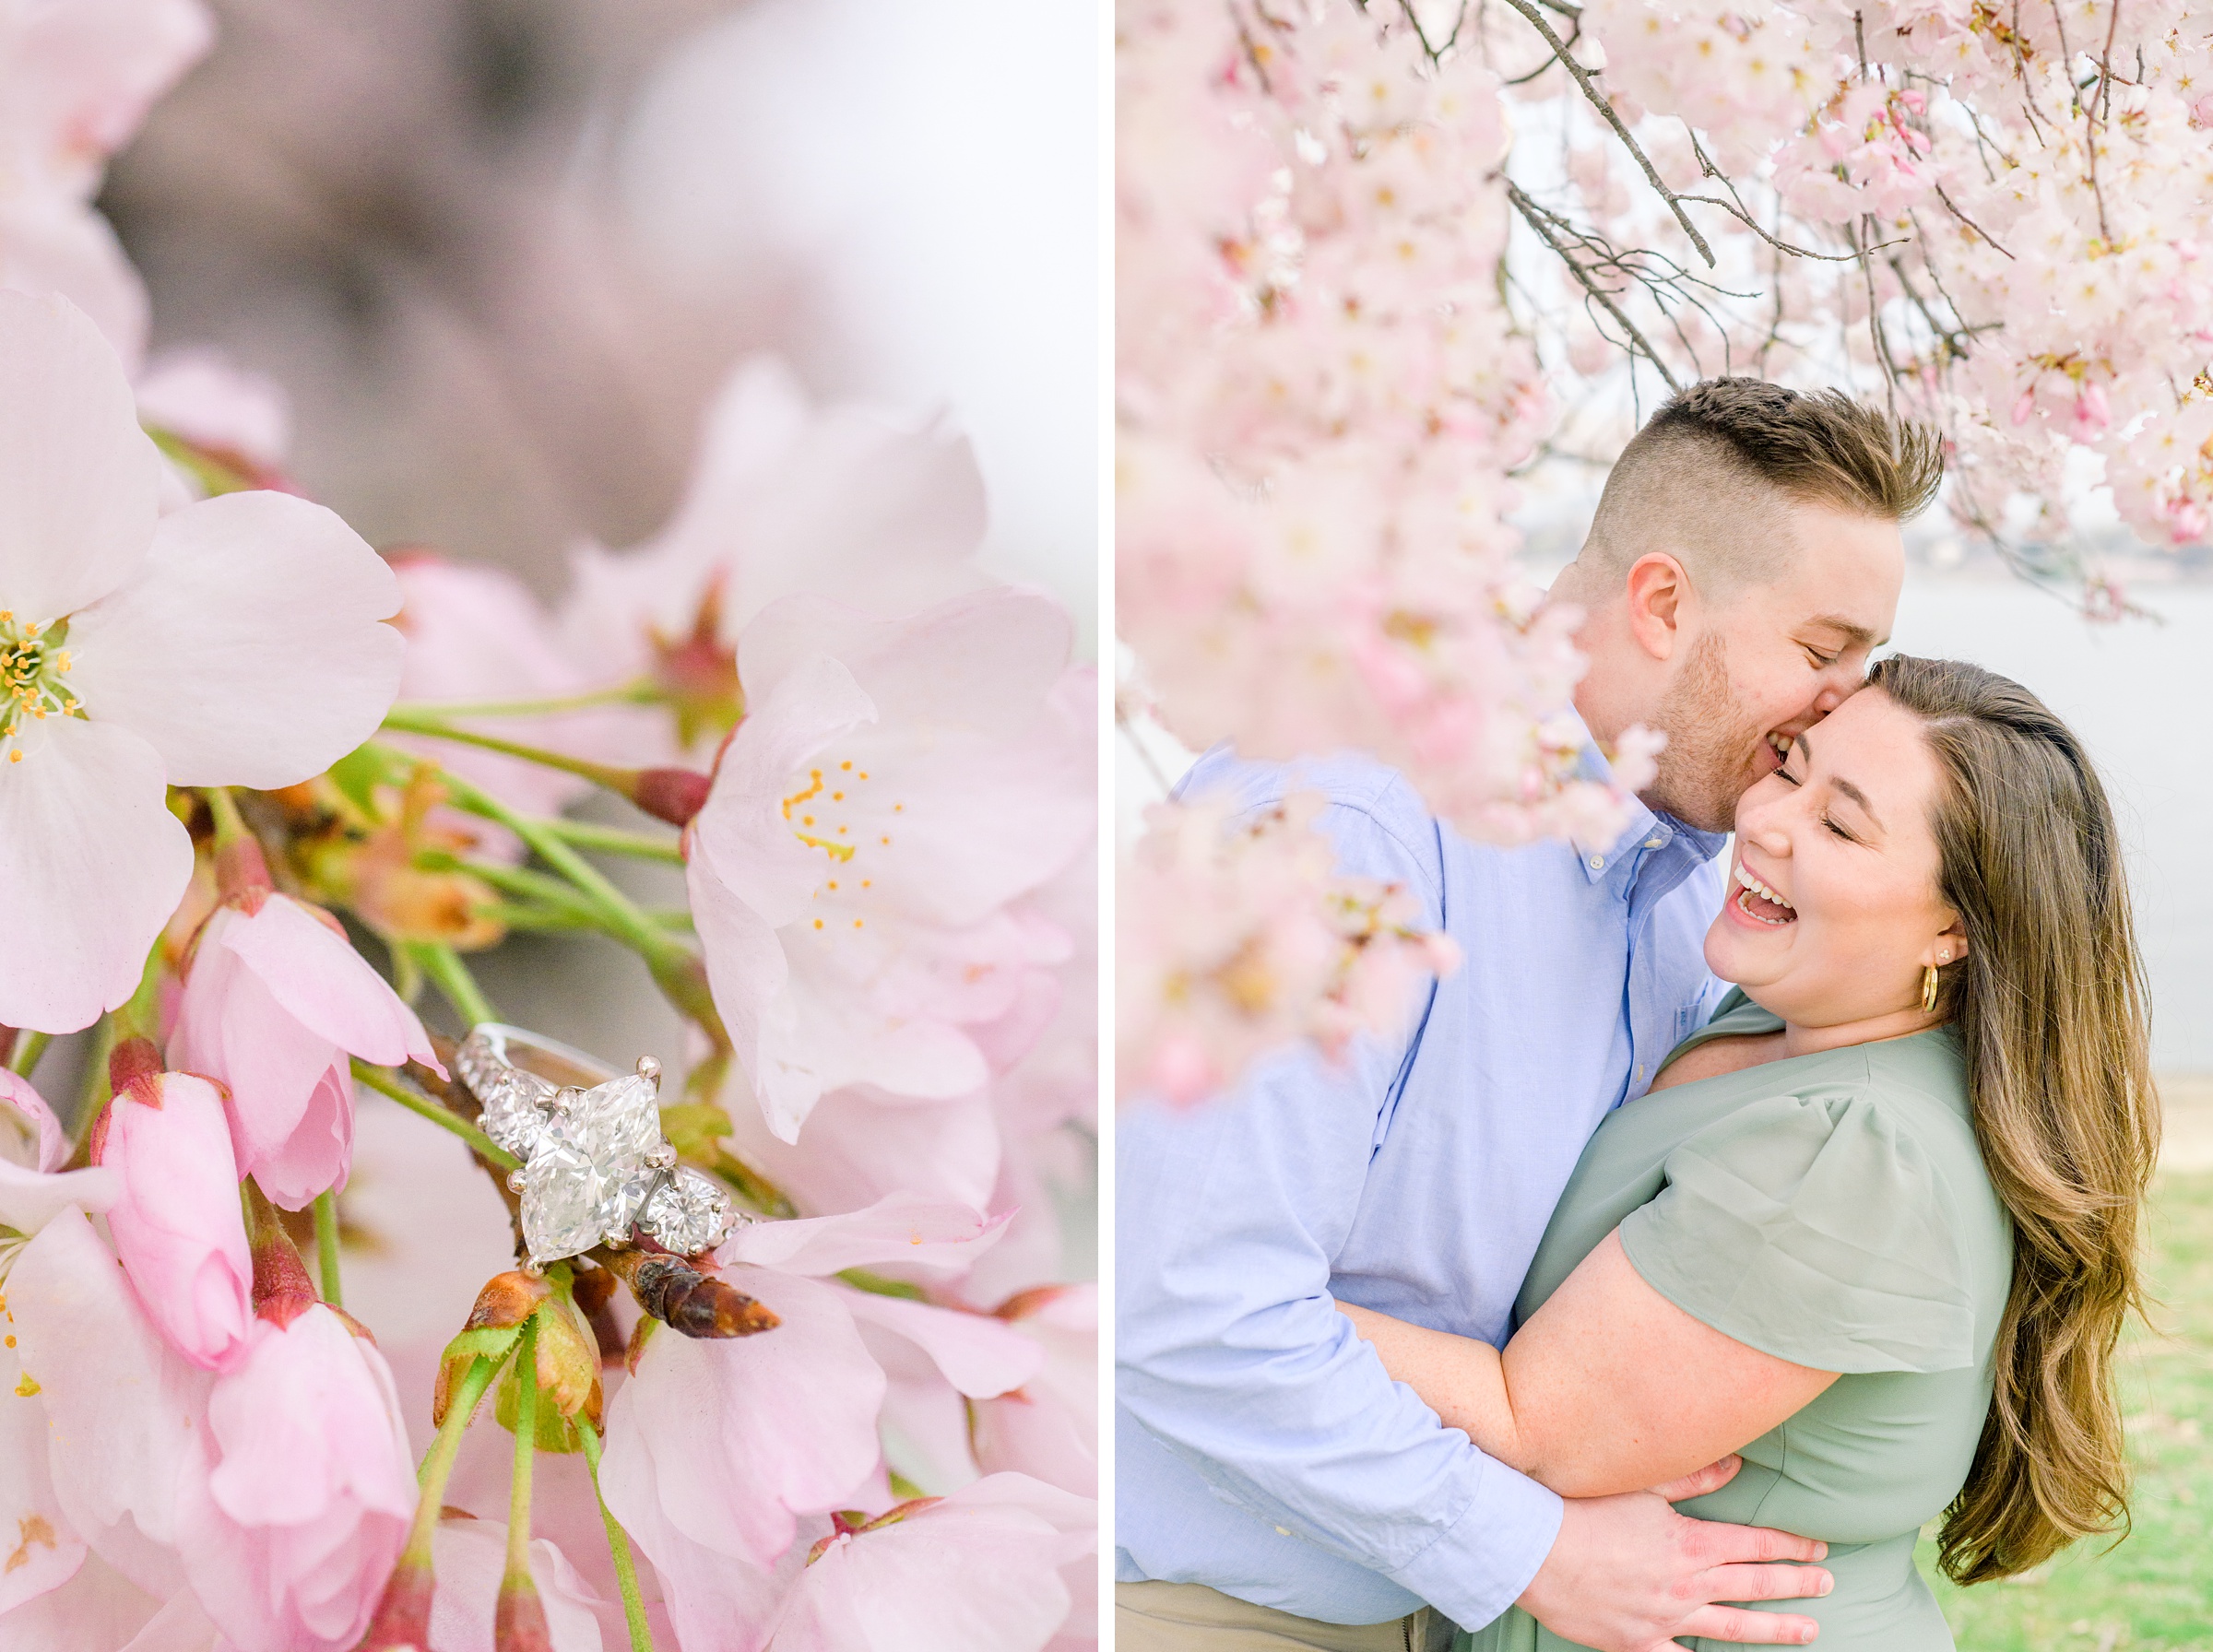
[1116,0,1663,1099]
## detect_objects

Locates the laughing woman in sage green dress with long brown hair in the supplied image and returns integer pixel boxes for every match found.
[1343,659,2158,1652]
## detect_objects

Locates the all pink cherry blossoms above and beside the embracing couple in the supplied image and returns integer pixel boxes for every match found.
[1116,0,2213,1105]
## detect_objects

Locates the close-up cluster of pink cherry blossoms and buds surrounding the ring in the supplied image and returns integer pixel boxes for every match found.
[0,0,1097,1652]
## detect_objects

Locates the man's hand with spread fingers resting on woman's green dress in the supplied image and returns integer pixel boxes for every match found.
[1521,1457,1835,1652]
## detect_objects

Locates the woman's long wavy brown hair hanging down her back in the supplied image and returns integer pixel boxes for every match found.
[1868,656,2160,1584]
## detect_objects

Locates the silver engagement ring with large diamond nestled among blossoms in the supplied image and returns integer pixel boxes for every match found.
[454,1021,740,1271]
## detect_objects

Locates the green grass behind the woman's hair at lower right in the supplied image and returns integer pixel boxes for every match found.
[1921,1174,2213,1652]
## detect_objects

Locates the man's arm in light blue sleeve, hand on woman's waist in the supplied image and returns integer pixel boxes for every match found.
[1116,783,1828,1652]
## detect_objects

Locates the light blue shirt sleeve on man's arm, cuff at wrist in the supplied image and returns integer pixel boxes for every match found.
[1116,791,1560,1628]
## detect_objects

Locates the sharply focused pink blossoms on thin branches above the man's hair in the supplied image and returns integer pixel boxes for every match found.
[1557,0,2213,547]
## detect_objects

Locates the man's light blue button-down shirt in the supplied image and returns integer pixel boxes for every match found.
[1116,749,1724,1628]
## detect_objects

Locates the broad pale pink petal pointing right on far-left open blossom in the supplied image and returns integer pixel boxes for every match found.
[68,493,408,789]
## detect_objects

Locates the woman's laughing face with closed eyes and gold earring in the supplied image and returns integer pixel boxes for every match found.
[1706,688,1968,1042]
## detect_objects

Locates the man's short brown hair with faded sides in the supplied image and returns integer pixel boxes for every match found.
[1578,378,1943,595]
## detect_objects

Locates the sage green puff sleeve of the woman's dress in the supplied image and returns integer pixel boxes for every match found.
[1622,1092,1976,1374]
